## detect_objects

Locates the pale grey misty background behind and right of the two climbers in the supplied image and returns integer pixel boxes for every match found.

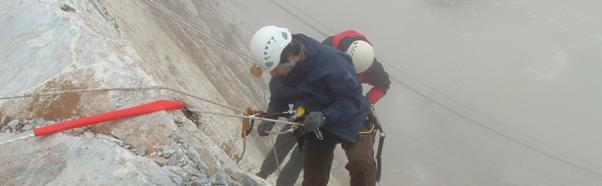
[235,0,602,185]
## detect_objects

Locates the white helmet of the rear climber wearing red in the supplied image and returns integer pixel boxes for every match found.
[347,40,374,74]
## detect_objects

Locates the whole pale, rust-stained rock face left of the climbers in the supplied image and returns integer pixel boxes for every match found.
[0,0,268,185]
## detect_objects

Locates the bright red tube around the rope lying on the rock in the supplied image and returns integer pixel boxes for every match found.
[33,100,185,136]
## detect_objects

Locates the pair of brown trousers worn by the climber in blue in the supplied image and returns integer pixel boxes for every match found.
[303,130,376,186]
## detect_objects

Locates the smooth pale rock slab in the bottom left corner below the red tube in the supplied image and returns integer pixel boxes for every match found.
[0,134,173,185]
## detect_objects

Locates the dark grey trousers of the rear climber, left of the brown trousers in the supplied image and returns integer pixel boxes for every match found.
[257,127,303,186]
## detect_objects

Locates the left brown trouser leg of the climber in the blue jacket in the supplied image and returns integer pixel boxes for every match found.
[303,132,337,186]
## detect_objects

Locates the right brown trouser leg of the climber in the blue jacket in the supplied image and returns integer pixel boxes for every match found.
[341,131,376,186]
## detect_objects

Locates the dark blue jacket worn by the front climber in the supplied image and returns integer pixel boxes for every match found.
[268,34,370,142]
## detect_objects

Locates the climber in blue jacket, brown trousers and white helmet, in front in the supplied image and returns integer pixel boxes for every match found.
[250,26,376,185]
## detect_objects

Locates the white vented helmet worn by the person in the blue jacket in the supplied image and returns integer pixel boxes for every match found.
[250,26,292,72]
